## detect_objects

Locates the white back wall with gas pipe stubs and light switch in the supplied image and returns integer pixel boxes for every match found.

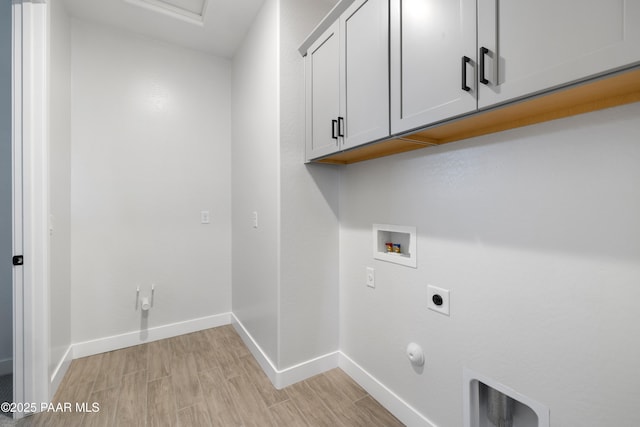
[71,20,231,343]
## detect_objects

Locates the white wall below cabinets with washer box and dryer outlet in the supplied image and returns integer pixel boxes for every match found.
[340,103,640,427]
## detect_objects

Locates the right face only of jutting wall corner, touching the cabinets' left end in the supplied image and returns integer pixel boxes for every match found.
[279,0,339,368]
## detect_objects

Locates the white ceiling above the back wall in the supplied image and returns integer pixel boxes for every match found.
[65,0,264,58]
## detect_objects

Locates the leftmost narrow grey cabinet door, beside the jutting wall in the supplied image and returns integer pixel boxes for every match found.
[305,22,340,160]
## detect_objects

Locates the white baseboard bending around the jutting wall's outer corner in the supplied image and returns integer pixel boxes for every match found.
[231,314,339,390]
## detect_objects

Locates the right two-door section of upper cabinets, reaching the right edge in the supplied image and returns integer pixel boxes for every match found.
[391,0,640,134]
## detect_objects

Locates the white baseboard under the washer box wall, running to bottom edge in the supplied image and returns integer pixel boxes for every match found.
[339,352,437,427]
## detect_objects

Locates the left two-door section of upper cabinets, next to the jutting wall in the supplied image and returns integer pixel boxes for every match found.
[305,0,389,160]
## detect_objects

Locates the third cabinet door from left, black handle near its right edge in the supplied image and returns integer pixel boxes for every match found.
[391,0,477,133]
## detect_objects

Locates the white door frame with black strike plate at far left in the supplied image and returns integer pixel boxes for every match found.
[11,0,51,418]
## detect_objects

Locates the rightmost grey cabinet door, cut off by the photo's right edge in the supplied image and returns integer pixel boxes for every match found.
[478,0,640,108]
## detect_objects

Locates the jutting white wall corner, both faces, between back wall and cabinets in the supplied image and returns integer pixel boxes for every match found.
[233,0,338,369]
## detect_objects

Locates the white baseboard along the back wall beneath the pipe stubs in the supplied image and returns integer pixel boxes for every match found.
[72,313,231,359]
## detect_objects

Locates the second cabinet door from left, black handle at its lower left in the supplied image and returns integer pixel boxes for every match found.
[340,0,389,149]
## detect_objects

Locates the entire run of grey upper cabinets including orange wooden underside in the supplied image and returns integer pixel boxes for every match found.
[299,0,640,163]
